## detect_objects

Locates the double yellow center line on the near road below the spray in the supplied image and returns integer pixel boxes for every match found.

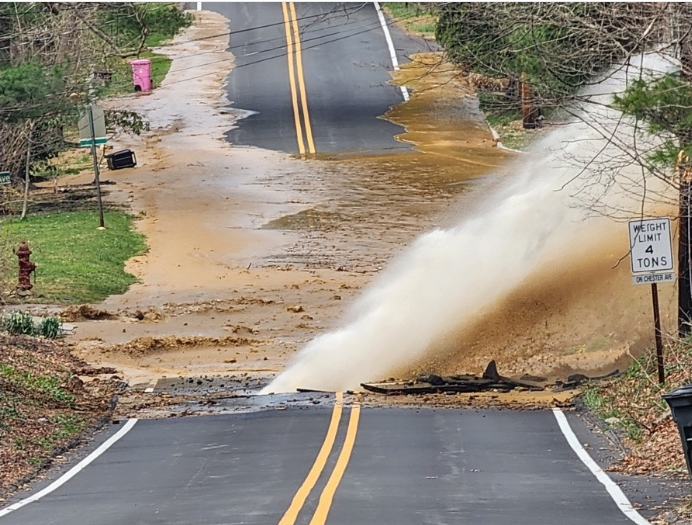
[279,392,360,525]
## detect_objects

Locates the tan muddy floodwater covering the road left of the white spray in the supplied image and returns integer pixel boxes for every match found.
[54,12,498,392]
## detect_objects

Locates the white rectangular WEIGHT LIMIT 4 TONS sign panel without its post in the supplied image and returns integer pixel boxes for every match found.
[629,217,675,284]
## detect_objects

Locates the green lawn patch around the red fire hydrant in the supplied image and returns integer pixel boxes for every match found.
[0,211,147,304]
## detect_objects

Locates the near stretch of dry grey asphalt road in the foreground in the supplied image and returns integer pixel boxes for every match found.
[0,400,656,525]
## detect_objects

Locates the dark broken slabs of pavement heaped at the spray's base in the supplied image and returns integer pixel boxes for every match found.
[361,361,618,395]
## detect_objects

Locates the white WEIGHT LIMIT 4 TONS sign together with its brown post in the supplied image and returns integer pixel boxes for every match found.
[629,217,675,384]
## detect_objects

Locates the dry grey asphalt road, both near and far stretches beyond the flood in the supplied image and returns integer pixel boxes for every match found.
[0,3,672,525]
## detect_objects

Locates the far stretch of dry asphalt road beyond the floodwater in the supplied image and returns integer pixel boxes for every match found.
[203,2,425,155]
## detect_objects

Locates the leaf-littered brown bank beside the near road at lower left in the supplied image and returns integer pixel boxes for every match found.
[0,334,117,501]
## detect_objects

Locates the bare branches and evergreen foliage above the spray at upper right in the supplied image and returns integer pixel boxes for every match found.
[437,2,692,171]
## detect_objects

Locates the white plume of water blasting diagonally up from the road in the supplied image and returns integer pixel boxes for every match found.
[262,55,672,393]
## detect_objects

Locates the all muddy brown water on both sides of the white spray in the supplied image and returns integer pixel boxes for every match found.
[51,12,668,392]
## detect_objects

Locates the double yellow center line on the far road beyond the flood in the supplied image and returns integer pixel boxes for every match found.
[281,2,315,155]
